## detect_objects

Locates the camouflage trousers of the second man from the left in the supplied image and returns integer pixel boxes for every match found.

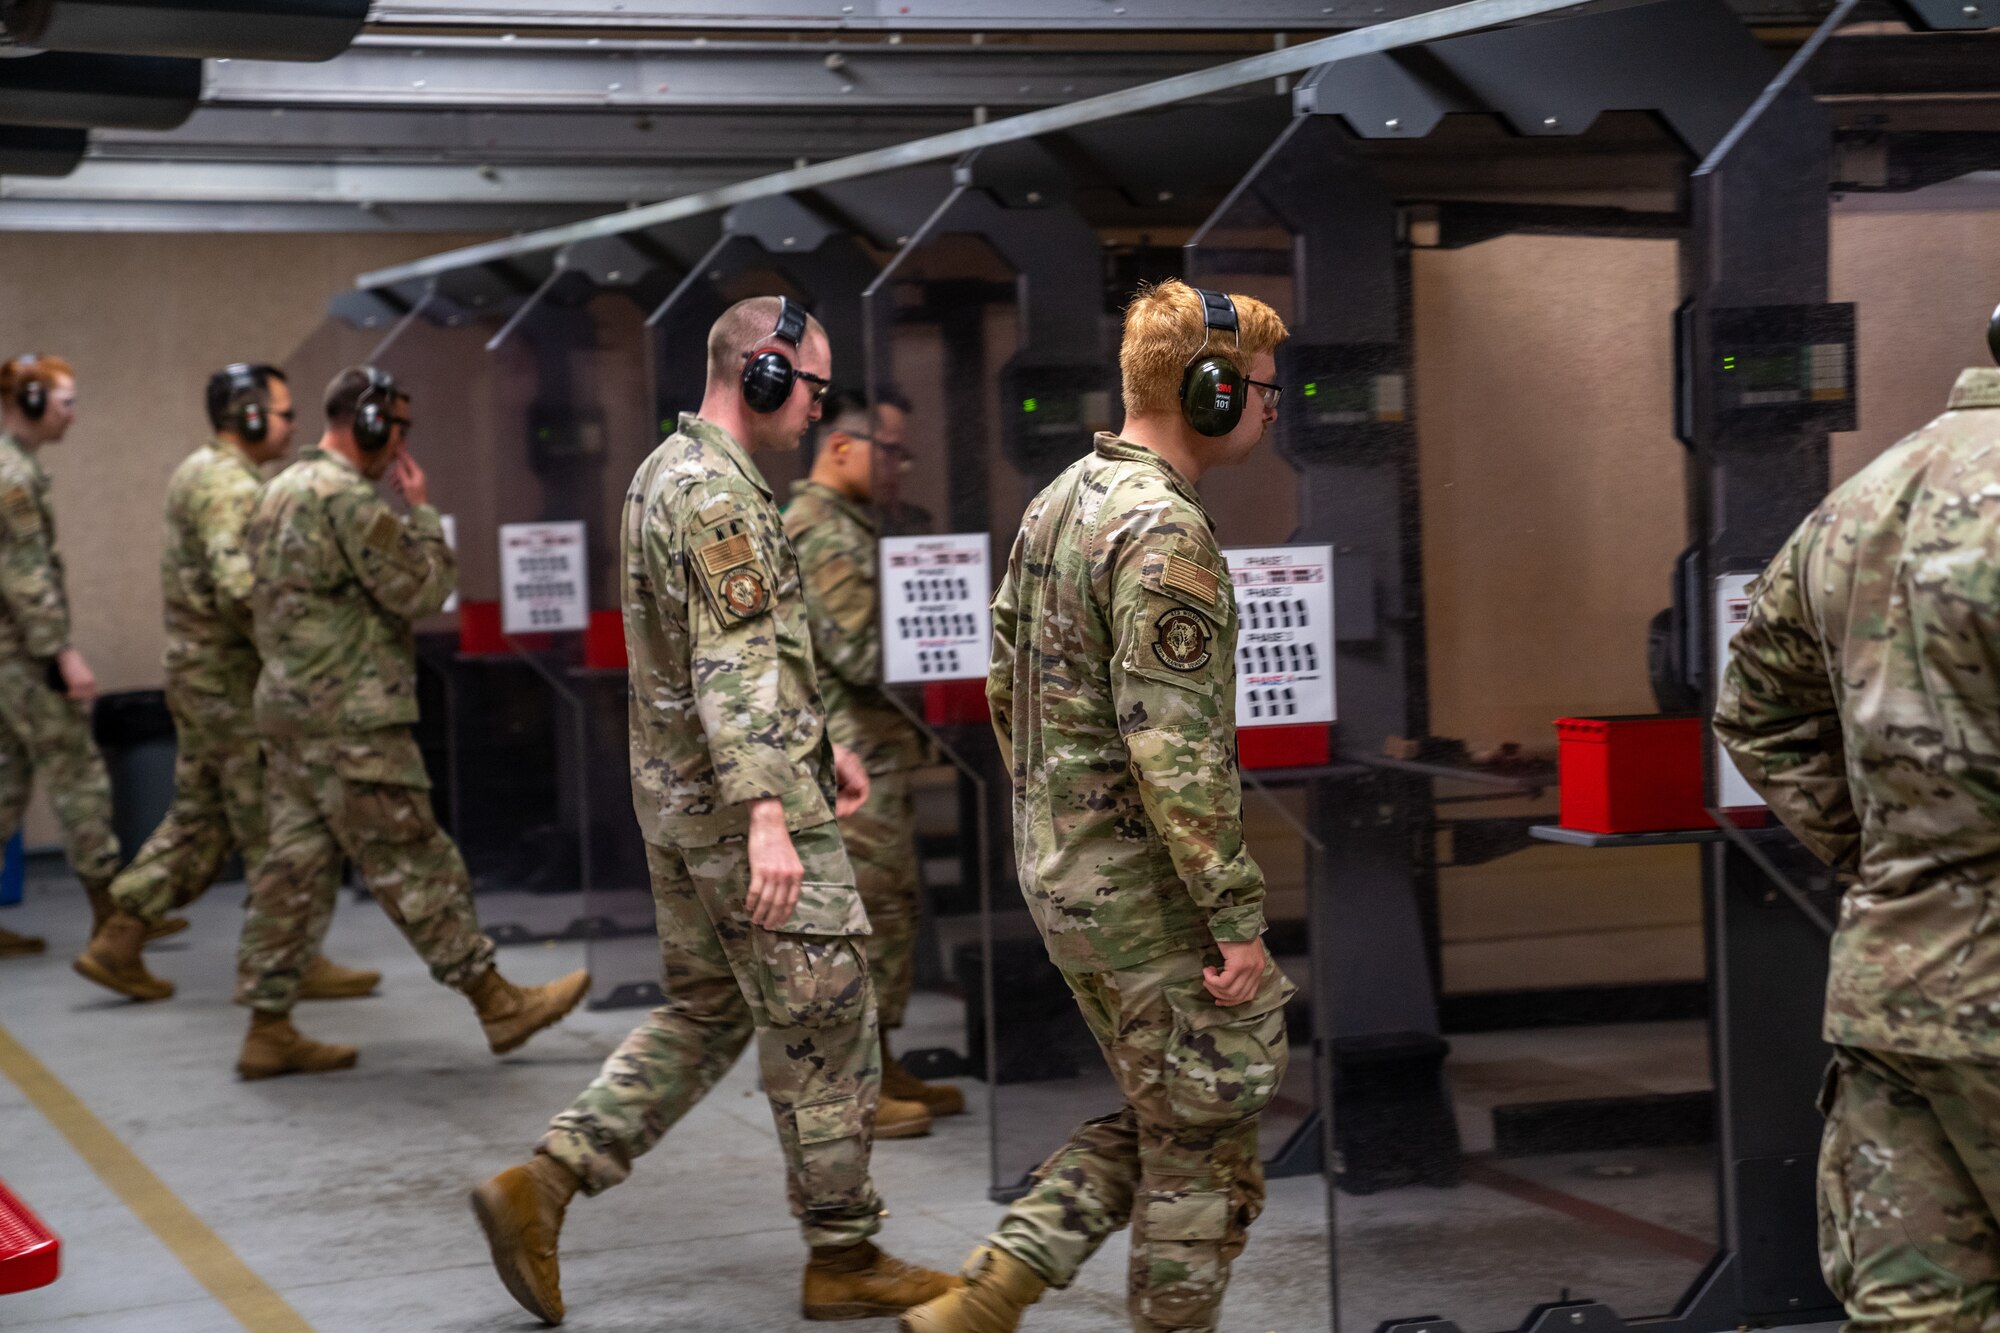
[112,691,264,921]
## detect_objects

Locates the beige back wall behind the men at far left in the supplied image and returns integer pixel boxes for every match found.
[0,232,492,845]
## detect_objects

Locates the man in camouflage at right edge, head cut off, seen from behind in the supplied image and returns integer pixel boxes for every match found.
[1716,360,2000,1331]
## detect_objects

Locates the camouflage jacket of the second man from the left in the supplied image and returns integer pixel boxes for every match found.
[160,440,264,721]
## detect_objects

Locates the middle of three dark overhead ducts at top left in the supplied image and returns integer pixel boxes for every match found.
[0,54,202,130]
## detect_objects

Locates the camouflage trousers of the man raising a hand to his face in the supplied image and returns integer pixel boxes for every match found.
[236,727,494,1015]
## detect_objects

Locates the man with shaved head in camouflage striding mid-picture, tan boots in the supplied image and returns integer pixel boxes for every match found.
[472,298,950,1323]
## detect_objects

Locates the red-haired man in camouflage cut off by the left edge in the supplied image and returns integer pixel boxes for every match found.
[0,356,118,957]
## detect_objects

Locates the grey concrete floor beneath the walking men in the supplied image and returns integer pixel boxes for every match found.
[0,879,1326,1333]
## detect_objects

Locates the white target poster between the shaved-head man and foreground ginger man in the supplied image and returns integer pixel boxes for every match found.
[880,532,992,685]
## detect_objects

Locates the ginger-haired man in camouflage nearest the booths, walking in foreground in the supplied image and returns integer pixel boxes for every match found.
[902,282,1294,1333]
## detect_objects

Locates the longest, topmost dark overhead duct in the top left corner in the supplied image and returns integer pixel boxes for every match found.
[0,0,368,60]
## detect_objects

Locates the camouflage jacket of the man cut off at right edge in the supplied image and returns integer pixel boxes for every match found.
[1716,370,2000,1063]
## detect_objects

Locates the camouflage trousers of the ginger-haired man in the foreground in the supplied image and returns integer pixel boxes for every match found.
[988,953,1288,1333]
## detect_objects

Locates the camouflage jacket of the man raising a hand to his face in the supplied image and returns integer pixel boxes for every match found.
[248,448,458,740]
